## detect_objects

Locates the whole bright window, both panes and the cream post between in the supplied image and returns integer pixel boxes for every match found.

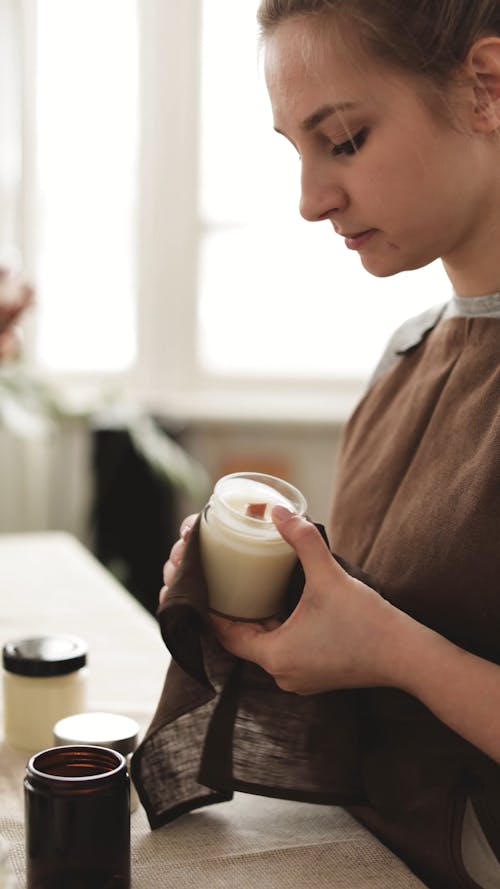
[8,0,448,410]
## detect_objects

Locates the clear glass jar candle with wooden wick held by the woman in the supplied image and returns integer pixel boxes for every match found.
[200,472,307,620]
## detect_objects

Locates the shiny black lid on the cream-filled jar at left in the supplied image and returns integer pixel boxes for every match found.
[2,636,87,676]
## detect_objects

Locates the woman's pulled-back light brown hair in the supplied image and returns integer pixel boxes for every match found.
[257,0,500,84]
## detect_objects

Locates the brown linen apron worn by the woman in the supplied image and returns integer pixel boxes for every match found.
[330,318,500,889]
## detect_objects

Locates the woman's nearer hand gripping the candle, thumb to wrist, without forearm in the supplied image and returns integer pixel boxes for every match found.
[212,507,409,694]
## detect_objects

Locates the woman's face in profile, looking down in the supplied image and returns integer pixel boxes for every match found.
[265,19,494,276]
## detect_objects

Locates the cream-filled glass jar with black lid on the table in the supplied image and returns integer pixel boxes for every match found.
[2,635,88,753]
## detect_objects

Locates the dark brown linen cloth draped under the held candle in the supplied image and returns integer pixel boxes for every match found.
[133,520,376,828]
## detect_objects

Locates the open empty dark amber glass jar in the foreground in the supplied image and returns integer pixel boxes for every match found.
[24,745,130,889]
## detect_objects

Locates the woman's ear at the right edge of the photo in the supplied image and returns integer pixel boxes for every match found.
[465,37,500,133]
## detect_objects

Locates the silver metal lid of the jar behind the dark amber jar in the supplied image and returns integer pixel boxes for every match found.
[54,713,139,756]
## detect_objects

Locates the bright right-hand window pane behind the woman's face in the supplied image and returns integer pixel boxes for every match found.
[198,0,450,378]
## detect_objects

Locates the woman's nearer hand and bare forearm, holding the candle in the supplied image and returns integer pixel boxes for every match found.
[211,507,500,763]
